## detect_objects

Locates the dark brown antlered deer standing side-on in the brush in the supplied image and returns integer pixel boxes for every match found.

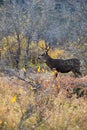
[38,44,82,77]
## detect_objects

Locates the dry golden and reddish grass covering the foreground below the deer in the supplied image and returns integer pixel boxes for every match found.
[0,74,87,130]
